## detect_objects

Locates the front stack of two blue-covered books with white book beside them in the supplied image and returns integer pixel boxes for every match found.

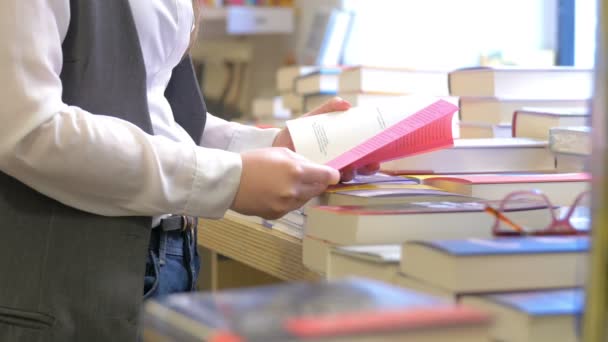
[327,236,589,342]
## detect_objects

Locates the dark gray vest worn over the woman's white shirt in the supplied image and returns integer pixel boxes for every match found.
[0,0,206,342]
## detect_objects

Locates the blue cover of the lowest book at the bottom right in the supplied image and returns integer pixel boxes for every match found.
[484,288,585,316]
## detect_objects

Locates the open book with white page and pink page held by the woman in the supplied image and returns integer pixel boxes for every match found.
[287,97,458,170]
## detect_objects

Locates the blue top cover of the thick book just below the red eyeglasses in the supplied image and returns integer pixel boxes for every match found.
[416,236,589,256]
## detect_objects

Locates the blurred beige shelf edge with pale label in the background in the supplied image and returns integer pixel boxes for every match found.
[200,6,294,36]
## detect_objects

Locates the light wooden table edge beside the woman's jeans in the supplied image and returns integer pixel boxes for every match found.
[198,213,320,290]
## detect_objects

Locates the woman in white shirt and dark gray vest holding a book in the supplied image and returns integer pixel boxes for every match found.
[0,0,377,341]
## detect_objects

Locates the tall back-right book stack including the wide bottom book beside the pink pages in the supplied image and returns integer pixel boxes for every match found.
[382,67,592,174]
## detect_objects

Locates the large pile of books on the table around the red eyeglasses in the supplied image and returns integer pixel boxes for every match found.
[296,68,591,341]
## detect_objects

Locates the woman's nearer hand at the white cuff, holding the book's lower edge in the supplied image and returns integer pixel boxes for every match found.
[231,147,340,219]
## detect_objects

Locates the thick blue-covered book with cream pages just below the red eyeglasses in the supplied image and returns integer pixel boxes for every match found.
[400,236,589,293]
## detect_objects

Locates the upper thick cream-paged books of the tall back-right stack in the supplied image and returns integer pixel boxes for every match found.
[449,67,592,140]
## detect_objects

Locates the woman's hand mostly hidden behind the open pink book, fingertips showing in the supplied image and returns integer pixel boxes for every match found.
[272,97,380,182]
